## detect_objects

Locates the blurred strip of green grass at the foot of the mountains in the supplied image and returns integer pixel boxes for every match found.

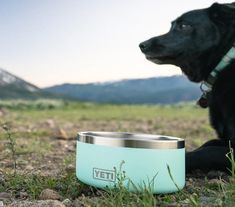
[0,100,206,121]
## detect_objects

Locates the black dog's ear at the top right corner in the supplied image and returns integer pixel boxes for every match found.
[208,2,235,24]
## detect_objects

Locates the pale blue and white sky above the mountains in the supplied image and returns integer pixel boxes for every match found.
[0,0,229,87]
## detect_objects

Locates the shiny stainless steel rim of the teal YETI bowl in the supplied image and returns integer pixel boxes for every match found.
[77,131,185,149]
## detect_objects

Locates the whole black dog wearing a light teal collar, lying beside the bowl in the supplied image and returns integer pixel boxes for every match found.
[139,2,235,172]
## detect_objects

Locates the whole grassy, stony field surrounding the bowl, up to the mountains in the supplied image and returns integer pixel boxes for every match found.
[0,100,235,207]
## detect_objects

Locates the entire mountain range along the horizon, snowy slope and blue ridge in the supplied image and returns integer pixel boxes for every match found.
[0,68,201,104]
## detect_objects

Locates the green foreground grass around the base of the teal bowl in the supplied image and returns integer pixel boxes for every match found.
[0,173,235,207]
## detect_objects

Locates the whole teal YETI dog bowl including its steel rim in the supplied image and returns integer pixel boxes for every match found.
[76,132,185,193]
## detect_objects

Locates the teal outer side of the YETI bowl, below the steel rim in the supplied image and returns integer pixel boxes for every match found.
[76,134,185,194]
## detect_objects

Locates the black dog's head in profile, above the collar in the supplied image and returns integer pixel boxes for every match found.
[139,3,235,82]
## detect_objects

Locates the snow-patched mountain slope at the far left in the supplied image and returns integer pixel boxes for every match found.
[0,68,55,99]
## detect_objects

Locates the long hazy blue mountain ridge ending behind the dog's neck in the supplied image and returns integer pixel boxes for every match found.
[44,76,201,104]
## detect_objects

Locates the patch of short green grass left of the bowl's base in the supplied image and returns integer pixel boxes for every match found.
[0,174,82,199]
